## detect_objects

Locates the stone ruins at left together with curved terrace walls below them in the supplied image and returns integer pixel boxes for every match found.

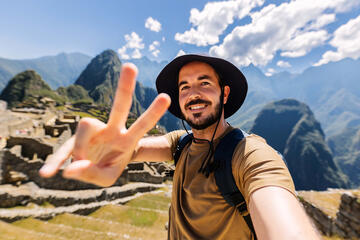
[0,106,173,222]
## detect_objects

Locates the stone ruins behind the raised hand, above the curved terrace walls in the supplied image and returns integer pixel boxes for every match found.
[0,109,171,190]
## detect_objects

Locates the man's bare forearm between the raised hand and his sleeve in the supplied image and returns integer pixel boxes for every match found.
[131,136,172,162]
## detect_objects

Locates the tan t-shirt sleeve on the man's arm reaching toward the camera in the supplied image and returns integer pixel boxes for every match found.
[232,135,296,205]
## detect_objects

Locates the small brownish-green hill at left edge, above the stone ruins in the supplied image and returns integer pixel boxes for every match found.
[0,70,64,108]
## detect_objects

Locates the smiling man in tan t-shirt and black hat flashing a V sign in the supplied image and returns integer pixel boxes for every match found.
[40,55,318,239]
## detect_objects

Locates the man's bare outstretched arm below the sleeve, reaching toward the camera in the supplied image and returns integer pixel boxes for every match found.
[249,186,320,240]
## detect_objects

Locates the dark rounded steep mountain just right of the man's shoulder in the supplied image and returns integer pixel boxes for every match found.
[250,99,349,190]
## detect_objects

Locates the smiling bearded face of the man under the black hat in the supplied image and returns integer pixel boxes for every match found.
[178,62,221,130]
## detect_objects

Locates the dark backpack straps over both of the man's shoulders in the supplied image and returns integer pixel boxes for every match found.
[173,129,257,240]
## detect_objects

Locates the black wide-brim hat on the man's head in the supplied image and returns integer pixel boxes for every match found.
[156,54,248,119]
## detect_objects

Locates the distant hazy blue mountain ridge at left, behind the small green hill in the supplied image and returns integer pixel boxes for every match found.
[0,53,91,91]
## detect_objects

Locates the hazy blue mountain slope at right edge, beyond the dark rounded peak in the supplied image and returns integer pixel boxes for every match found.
[328,126,360,188]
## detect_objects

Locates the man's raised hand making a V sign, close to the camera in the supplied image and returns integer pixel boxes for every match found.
[39,64,170,186]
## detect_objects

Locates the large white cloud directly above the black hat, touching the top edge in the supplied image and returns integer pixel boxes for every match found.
[175,0,264,46]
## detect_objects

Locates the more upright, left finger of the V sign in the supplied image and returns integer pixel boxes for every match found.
[108,63,137,128]
